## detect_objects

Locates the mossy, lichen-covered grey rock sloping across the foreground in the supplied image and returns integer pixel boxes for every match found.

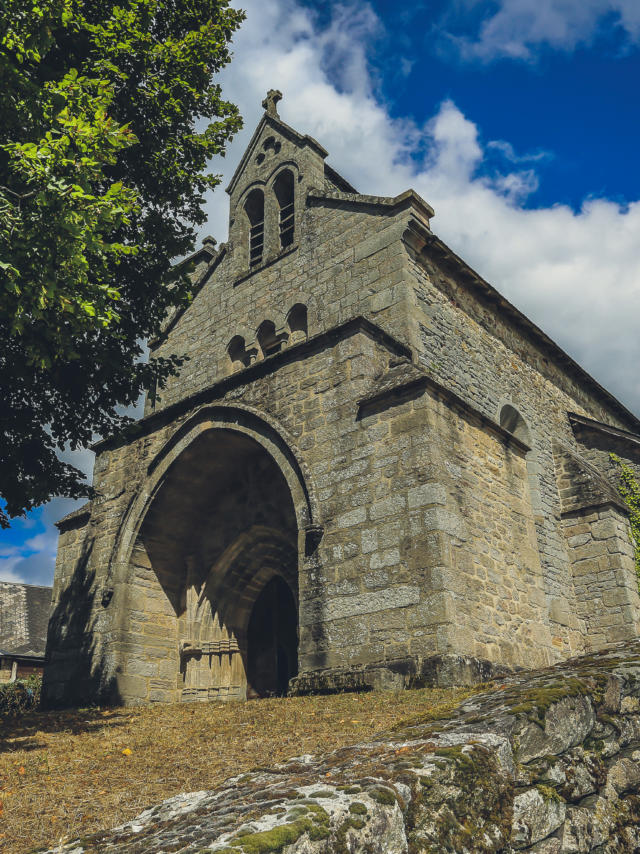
[41,642,640,854]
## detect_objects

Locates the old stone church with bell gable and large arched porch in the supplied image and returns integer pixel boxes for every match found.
[44,91,640,706]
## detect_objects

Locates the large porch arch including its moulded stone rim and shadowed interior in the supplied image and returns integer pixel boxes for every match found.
[107,405,321,701]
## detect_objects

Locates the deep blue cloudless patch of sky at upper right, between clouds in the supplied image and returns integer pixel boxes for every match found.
[378,2,640,208]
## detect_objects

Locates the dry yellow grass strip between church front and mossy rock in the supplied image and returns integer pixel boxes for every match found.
[0,689,469,854]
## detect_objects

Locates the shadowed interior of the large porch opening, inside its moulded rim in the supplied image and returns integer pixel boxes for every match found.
[129,429,299,700]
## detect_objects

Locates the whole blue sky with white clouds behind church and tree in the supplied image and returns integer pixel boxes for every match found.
[0,0,640,584]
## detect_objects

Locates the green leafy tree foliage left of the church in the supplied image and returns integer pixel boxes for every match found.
[0,0,244,526]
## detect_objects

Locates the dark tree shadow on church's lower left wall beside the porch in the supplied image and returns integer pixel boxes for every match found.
[41,537,122,709]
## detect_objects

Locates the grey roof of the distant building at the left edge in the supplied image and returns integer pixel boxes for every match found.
[0,581,52,657]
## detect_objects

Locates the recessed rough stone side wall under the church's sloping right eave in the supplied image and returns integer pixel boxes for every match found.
[404,241,637,664]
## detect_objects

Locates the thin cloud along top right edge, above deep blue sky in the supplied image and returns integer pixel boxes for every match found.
[441,0,640,62]
